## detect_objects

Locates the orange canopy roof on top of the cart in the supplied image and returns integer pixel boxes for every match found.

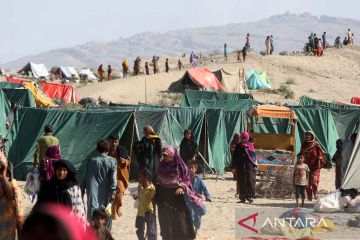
[248,105,296,119]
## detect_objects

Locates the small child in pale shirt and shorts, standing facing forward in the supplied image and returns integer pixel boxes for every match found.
[293,153,310,207]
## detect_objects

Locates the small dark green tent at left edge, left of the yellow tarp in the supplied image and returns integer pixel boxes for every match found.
[2,88,36,108]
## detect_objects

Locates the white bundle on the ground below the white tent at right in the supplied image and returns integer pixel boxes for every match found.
[314,188,360,213]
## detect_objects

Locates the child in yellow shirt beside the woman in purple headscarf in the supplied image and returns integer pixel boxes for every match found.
[135,168,156,240]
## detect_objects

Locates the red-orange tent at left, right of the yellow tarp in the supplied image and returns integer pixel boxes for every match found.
[40,82,79,103]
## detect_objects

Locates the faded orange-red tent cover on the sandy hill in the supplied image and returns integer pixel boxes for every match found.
[187,68,224,91]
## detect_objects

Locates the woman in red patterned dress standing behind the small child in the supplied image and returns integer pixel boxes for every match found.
[300,131,324,201]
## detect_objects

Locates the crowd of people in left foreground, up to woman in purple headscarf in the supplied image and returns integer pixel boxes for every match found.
[0,125,211,240]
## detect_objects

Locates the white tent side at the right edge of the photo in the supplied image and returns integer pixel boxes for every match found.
[341,134,360,189]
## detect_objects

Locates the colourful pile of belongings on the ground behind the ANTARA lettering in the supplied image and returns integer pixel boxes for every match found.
[260,208,335,238]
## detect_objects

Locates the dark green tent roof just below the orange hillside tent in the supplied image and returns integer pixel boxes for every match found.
[180,90,253,107]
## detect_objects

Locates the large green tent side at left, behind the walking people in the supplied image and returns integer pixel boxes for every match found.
[8,108,132,179]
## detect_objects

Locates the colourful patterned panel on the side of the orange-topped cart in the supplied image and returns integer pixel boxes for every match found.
[256,149,291,165]
